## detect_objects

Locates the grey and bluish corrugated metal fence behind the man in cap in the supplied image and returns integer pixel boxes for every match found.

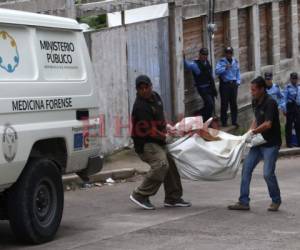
[87,18,171,153]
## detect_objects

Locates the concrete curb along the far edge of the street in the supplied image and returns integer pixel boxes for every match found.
[63,148,300,186]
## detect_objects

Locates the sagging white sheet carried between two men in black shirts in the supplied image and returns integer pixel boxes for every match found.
[168,118,264,181]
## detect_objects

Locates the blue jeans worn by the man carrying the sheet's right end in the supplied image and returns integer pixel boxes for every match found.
[239,146,281,205]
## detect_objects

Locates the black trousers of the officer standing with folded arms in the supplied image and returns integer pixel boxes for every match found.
[219,81,238,126]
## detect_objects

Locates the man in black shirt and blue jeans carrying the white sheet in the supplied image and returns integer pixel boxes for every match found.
[228,77,281,211]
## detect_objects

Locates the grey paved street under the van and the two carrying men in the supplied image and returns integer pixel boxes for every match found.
[0,158,300,250]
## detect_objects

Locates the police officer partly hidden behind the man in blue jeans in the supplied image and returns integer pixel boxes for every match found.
[265,72,286,113]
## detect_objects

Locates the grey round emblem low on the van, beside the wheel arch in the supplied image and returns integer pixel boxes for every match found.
[2,124,18,162]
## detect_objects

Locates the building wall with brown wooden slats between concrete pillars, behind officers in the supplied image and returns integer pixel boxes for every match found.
[183,0,300,120]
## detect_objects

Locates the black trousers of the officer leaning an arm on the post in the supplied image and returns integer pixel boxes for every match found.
[197,86,215,121]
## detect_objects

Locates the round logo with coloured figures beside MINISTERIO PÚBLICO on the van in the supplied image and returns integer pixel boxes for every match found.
[0,31,20,73]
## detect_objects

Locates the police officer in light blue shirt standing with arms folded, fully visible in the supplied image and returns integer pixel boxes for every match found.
[216,47,241,127]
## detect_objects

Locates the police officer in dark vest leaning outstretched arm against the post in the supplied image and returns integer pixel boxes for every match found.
[184,48,217,121]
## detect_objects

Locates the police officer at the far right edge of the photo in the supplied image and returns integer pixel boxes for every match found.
[283,72,300,147]
